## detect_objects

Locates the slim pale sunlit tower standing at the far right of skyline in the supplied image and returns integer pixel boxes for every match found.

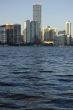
[66,21,71,45]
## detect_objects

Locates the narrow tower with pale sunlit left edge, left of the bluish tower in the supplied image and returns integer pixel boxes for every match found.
[23,20,30,43]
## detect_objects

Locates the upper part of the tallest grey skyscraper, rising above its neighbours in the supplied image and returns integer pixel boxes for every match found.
[33,5,41,28]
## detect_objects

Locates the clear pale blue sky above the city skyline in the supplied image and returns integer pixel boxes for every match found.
[0,0,73,30]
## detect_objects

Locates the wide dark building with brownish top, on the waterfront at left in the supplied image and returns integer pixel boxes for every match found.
[1,24,21,45]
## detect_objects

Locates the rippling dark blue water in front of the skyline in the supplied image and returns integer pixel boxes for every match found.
[0,47,73,110]
